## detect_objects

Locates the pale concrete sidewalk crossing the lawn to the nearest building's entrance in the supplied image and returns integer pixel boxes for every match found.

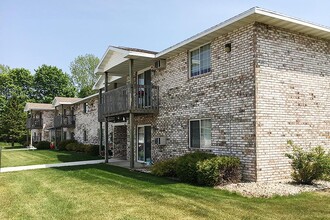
[0,160,104,173]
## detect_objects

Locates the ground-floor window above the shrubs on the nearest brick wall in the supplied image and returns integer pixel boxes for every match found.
[189,119,212,148]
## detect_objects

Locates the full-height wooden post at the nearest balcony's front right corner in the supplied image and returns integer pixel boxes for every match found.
[128,59,134,168]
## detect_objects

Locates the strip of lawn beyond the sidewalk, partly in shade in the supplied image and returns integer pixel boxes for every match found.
[1,150,101,167]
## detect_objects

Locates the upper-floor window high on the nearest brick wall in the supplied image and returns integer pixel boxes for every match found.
[190,44,211,77]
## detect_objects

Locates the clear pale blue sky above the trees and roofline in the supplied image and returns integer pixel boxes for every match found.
[0,0,330,73]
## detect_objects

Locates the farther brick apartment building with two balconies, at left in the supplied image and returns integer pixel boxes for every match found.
[24,94,99,148]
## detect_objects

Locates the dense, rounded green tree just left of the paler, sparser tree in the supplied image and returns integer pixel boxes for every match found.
[34,65,76,103]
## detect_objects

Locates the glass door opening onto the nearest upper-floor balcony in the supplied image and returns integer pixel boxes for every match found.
[138,70,151,108]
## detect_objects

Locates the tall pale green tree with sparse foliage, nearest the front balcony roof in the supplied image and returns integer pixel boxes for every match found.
[70,54,100,98]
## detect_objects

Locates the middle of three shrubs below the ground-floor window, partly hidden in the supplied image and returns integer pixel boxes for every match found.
[175,152,216,184]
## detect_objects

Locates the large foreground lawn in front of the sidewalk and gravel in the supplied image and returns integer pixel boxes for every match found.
[0,164,330,219]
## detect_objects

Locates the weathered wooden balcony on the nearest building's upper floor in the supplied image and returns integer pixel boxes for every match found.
[99,84,159,119]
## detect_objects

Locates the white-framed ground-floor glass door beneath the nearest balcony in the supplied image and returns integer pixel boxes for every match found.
[137,126,151,162]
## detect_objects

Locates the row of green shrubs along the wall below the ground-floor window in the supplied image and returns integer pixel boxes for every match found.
[151,152,241,186]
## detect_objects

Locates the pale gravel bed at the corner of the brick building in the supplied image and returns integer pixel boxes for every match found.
[216,181,330,198]
